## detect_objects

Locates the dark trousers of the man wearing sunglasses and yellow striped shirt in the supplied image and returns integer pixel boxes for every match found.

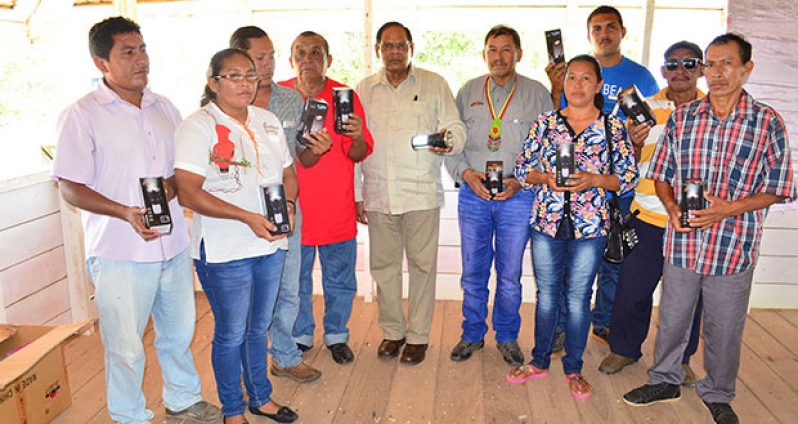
[610,218,701,364]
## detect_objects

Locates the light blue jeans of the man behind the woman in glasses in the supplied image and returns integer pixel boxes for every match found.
[269,203,302,368]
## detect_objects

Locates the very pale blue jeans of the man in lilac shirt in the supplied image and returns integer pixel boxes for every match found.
[86,250,201,423]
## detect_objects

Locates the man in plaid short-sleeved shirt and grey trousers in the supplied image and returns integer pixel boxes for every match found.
[624,33,796,423]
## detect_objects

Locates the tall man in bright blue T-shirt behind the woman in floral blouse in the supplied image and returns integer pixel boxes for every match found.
[546,6,659,353]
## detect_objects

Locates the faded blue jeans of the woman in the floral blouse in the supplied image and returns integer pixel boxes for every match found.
[530,230,607,374]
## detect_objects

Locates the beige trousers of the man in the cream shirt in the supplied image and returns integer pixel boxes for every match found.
[366,208,440,344]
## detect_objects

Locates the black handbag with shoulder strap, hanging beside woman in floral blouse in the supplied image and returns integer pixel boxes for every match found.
[604,115,640,264]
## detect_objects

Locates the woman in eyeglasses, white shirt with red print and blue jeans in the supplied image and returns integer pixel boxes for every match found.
[175,49,297,424]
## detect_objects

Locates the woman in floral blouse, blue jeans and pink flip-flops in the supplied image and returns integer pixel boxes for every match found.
[507,55,638,400]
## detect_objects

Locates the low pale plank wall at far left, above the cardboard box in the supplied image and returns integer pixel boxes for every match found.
[0,175,72,325]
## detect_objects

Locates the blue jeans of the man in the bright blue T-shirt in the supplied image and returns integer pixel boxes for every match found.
[557,192,634,333]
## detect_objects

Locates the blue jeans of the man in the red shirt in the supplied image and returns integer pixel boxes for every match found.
[294,239,357,346]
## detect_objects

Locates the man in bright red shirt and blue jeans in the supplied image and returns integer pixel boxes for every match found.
[279,31,374,364]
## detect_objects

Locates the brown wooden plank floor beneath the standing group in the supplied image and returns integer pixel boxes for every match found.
[55,295,798,424]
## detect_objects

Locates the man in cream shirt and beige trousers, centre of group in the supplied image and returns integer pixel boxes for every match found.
[357,22,465,365]
